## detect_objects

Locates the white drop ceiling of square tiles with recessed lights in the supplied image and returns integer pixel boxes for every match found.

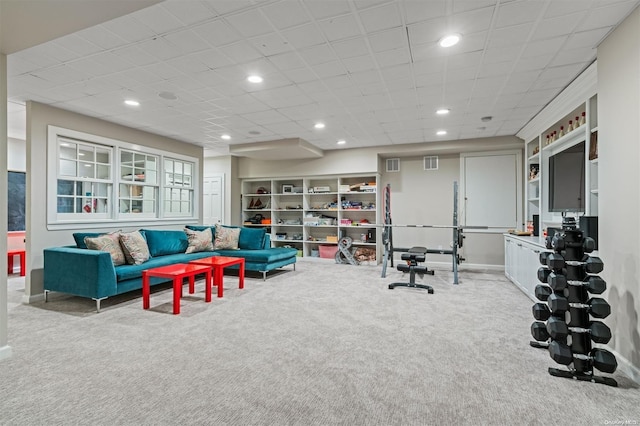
[7,0,640,155]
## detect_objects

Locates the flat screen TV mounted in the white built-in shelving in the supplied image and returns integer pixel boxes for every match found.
[549,142,585,212]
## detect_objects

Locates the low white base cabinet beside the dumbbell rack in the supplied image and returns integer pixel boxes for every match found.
[504,234,546,302]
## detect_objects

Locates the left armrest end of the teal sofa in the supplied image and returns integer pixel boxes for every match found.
[43,247,117,299]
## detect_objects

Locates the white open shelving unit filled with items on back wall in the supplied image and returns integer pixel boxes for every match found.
[242,175,382,263]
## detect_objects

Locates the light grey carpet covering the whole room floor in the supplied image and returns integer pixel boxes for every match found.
[0,261,640,425]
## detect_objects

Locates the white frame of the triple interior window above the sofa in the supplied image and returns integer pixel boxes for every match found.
[47,125,200,230]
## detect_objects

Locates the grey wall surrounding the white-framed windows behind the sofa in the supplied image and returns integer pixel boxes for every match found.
[24,101,203,303]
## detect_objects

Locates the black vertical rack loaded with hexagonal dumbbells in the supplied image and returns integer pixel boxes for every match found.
[530,217,618,386]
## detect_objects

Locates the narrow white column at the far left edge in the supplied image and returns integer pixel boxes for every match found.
[0,53,11,360]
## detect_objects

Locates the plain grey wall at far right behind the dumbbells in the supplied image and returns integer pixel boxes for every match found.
[598,5,640,380]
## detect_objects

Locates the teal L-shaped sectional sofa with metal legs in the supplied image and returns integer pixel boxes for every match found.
[44,226,297,312]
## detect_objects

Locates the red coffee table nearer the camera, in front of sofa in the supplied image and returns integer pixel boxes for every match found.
[142,263,211,315]
